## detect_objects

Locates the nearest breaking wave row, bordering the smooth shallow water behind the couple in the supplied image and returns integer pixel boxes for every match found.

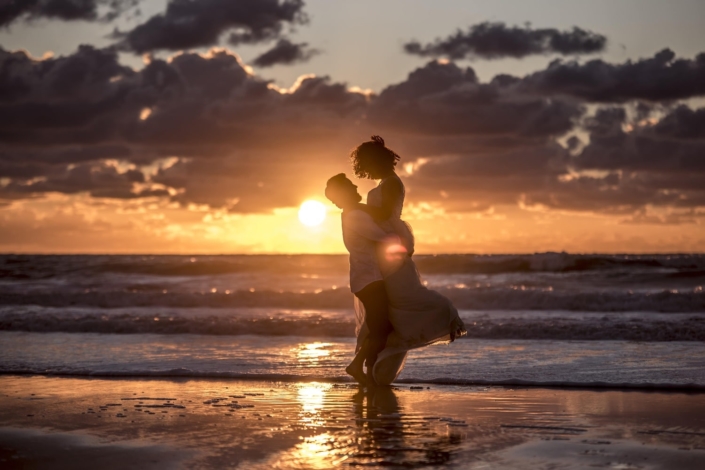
[0,310,705,342]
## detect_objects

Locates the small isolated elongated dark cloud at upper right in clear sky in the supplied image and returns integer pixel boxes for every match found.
[404,22,607,59]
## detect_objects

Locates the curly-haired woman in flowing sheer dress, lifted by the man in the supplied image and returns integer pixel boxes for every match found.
[346,135,467,385]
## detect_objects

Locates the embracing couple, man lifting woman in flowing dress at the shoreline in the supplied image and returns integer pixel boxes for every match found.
[325,136,466,385]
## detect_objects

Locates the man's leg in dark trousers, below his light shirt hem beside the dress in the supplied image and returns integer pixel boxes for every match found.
[355,281,393,376]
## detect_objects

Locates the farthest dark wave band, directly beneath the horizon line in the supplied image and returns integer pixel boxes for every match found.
[0,252,705,280]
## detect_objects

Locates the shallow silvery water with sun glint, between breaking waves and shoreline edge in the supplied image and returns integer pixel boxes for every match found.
[0,332,705,389]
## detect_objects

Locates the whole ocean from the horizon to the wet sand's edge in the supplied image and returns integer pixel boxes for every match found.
[0,253,705,390]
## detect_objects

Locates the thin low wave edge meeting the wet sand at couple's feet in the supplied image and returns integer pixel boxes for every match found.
[0,368,705,392]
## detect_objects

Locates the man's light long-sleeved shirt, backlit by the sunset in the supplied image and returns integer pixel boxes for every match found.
[341,209,388,292]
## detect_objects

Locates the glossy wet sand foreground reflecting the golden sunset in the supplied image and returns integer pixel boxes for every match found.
[0,376,705,470]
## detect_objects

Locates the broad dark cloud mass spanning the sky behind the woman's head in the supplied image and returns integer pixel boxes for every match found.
[0,39,705,219]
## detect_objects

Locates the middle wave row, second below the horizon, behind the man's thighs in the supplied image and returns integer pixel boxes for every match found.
[0,287,705,313]
